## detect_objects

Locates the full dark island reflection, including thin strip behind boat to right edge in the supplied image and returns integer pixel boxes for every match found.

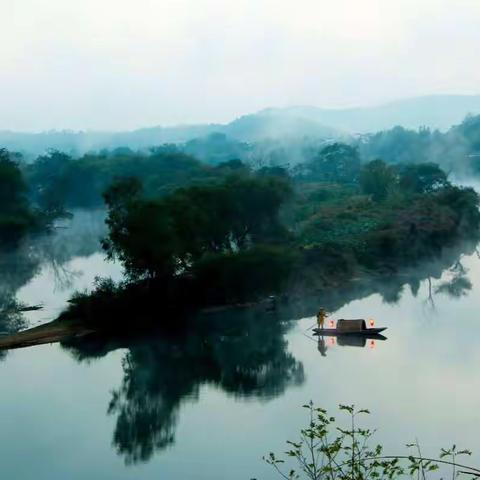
[58,237,480,463]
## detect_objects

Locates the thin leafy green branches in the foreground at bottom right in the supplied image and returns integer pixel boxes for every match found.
[264,402,480,480]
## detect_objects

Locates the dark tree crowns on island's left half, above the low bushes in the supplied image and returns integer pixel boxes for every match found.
[104,175,291,277]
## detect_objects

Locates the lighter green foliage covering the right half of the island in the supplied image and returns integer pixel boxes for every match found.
[297,171,480,271]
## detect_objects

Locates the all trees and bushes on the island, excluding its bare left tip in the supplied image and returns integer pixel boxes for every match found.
[94,149,480,312]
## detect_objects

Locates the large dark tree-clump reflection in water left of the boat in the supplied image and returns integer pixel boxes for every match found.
[65,314,304,463]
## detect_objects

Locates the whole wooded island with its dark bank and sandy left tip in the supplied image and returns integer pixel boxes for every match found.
[0,143,480,348]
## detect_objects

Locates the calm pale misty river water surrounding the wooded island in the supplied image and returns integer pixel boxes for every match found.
[0,207,480,480]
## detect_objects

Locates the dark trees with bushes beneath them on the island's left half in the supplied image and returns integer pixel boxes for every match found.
[93,172,295,312]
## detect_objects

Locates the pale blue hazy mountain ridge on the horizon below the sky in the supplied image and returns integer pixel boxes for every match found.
[0,95,480,156]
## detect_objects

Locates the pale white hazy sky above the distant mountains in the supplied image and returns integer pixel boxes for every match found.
[0,0,480,130]
